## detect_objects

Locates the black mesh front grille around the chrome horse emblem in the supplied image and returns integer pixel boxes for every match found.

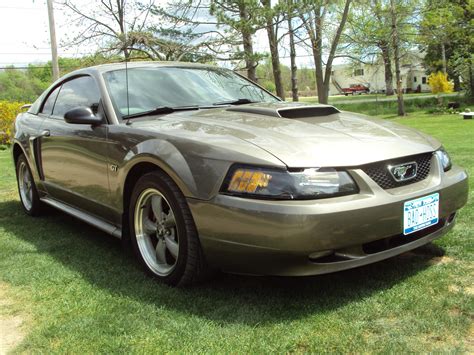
[361,153,433,190]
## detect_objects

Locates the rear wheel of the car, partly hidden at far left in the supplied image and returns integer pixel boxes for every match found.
[16,154,44,217]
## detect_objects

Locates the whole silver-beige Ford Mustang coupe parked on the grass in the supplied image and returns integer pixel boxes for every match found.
[13,62,468,286]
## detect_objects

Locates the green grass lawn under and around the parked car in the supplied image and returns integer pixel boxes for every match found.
[0,113,474,353]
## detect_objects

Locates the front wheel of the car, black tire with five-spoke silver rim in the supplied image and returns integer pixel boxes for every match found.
[129,171,209,287]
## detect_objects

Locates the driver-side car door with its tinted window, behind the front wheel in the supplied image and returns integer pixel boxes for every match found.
[41,75,111,219]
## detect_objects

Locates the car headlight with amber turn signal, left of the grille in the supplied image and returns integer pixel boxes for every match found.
[221,166,359,200]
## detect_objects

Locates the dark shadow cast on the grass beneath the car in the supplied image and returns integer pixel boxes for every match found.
[0,201,444,326]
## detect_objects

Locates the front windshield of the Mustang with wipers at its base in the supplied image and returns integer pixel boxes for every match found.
[104,67,278,116]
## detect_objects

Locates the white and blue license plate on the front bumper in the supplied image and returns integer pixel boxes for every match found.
[403,193,439,235]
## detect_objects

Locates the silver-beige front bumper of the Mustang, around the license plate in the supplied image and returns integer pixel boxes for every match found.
[188,158,468,276]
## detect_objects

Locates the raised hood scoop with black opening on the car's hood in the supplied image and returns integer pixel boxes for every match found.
[227,105,341,119]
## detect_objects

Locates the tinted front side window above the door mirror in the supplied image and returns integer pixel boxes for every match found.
[53,76,100,117]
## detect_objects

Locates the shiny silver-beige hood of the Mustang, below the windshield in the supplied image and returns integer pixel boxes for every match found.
[134,103,440,168]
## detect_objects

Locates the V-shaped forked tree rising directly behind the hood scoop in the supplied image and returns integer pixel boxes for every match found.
[299,0,352,104]
